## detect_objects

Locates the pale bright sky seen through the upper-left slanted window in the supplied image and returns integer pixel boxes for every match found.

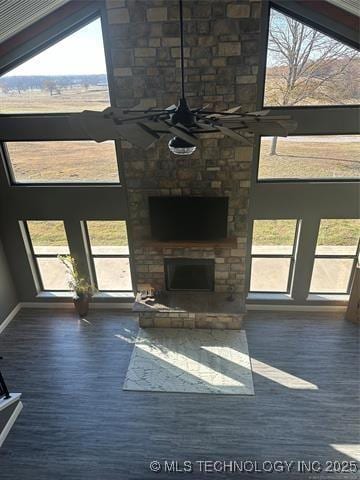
[6,19,106,76]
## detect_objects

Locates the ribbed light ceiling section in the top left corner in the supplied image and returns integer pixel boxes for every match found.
[0,0,69,43]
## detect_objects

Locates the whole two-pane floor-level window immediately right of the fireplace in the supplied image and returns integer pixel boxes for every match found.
[250,220,298,293]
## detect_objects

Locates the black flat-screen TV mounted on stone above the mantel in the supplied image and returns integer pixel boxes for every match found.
[149,197,228,241]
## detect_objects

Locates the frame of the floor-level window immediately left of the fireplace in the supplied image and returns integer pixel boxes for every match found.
[81,219,133,293]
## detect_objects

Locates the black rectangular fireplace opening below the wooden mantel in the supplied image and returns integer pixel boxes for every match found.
[164,258,215,292]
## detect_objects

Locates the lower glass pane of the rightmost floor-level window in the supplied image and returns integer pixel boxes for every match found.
[310,258,353,293]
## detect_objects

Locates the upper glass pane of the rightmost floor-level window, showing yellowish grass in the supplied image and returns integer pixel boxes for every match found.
[316,219,360,256]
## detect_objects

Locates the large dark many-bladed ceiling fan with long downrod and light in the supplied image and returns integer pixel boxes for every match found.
[69,0,297,155]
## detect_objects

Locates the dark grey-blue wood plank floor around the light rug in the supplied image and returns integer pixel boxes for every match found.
[0,310,360,480]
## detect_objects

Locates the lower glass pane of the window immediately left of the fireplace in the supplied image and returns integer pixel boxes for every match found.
[94,257,132,291]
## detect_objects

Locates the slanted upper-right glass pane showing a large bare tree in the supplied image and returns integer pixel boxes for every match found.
[264,10,360,106]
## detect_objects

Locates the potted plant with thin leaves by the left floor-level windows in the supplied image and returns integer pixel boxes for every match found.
[58,255,96,317]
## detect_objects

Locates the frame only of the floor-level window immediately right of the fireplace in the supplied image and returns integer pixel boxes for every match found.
[248,218,301,295]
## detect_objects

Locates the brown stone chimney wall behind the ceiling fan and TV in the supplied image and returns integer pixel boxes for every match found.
[107,0,261,295]
